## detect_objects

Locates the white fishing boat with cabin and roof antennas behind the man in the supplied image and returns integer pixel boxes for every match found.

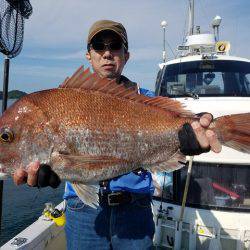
[1,0,250,250]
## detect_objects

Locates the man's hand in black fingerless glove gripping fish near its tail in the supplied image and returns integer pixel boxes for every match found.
[178,113,221,155]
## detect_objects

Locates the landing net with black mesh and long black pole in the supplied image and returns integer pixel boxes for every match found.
[0,0,32,232]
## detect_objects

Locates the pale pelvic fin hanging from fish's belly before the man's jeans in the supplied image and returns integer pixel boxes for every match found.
[71,182,99,208]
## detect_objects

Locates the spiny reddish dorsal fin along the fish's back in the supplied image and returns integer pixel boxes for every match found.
[60,66,194,117]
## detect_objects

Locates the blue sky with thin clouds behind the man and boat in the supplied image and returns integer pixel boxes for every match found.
[0,0,250,93]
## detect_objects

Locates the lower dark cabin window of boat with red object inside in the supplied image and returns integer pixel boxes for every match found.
[155,162,250,209]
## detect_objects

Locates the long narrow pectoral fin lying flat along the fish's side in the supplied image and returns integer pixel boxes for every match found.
[51,152,127,170]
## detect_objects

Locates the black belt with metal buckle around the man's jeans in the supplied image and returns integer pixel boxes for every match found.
[99,192,151,206]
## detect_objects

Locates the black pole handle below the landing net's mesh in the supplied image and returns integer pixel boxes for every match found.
[0,58,10,233]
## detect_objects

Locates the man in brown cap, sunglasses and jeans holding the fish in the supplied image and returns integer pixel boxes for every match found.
[14,20,221,250]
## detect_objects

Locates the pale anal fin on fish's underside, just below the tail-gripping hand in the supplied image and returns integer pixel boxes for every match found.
[149,151,186,172]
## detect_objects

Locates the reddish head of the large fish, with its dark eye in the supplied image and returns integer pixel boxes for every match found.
[0,96,51,174]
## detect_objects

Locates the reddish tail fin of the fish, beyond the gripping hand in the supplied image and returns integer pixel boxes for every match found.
[215,113,250,154]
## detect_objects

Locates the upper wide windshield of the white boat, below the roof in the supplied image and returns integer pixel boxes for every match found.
[156,60,250,97]
